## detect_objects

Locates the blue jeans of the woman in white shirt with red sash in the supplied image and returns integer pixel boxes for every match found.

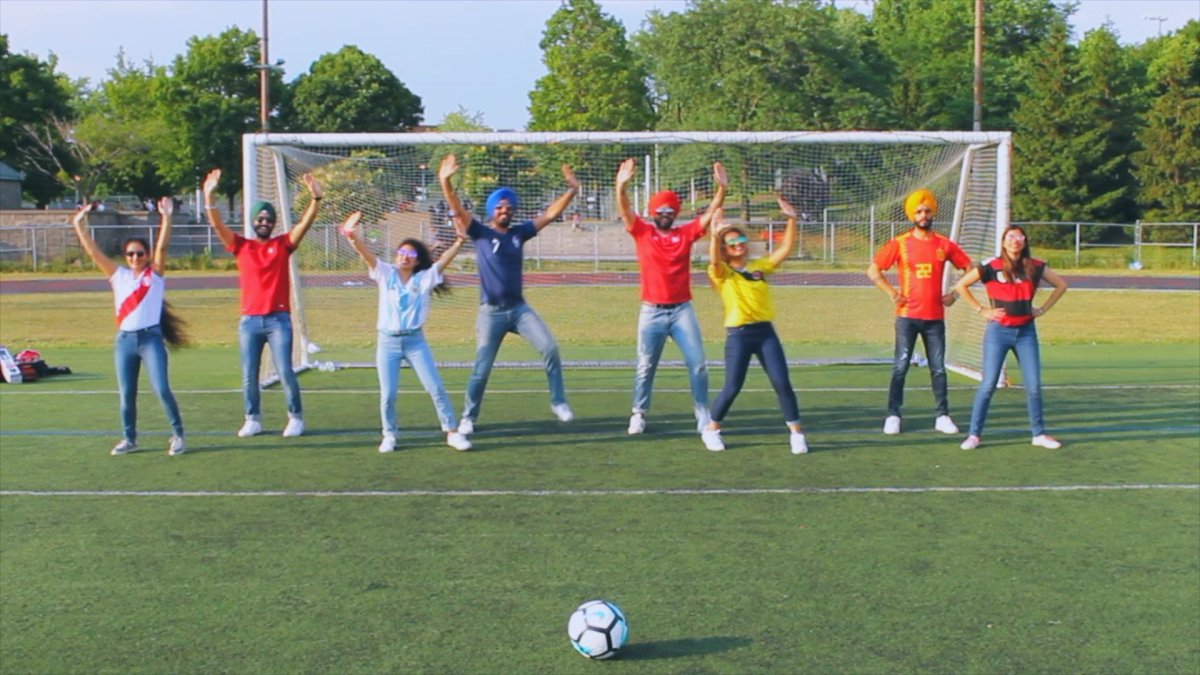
[113,325,184,443]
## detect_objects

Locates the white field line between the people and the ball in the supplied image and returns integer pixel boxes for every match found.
[0,483,1200,497]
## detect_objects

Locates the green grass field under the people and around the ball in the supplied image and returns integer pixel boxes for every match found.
[0,284,1200,674]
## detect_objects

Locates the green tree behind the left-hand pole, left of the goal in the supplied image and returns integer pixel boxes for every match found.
[161,28,283,197]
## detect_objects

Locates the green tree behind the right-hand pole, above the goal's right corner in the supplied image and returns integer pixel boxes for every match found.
[871,0,1070,130]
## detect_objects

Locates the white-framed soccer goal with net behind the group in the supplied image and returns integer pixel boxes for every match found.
[242,132,1010,377]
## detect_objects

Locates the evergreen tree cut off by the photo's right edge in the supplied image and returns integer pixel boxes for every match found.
[1134,20,1200,230]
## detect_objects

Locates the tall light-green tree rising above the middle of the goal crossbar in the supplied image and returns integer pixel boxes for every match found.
[529,0,654,131]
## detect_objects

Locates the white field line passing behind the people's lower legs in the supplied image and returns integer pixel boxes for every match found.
[0,383,1200,396]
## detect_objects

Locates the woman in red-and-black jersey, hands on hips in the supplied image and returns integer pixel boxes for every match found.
[954,225,1067,450]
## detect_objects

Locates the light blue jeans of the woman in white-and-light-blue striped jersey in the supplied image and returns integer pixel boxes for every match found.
[376,330,457,436]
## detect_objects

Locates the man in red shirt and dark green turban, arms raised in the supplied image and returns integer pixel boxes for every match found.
[204,169,324,437]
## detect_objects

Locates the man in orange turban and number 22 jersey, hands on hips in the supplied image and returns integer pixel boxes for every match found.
[866,190,971,435]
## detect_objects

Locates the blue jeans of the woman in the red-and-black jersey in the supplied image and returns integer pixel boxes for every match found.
[970,321,1046,436]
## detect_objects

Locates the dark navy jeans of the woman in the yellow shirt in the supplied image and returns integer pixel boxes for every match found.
[713,321,800,424]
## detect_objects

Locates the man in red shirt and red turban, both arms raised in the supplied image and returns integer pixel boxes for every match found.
[617,159,728,434]
